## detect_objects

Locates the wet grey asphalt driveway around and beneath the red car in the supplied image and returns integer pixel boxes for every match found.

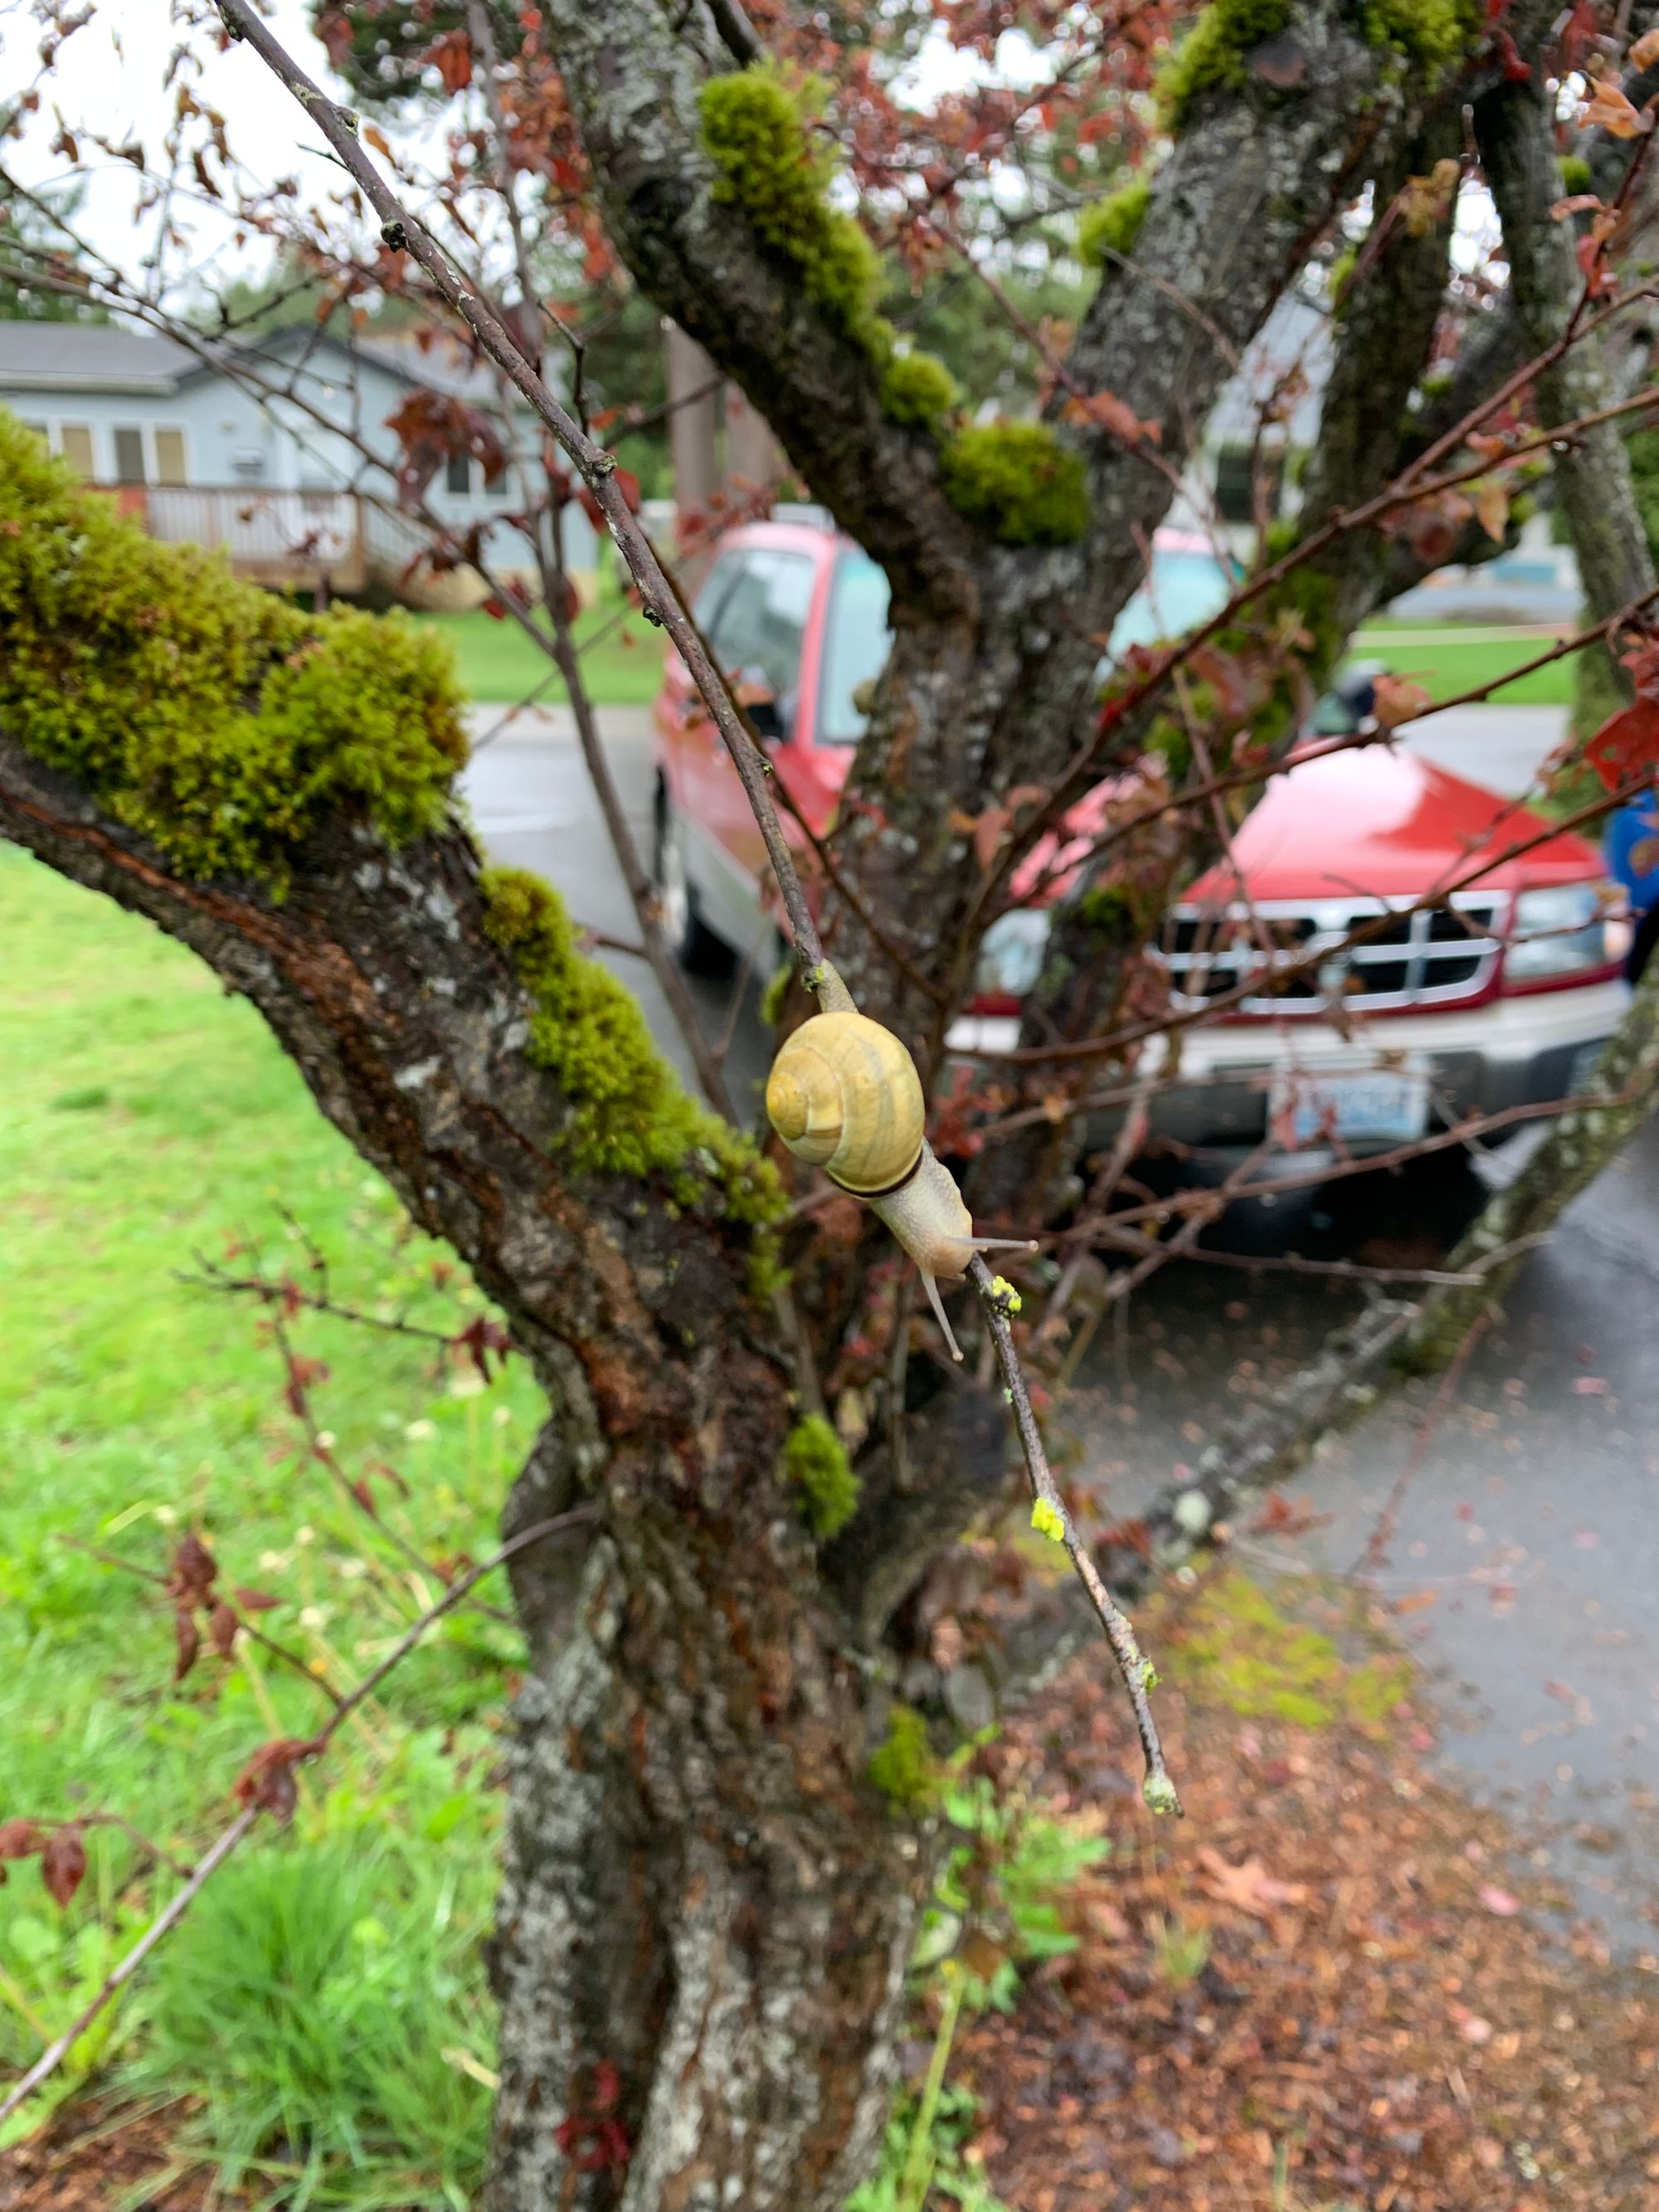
[467,707,1659,1957]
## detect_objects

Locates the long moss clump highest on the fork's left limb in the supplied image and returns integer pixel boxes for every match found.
[697,64,893,361]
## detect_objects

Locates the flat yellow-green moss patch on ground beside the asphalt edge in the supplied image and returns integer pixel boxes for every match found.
[1165,1573,1411,1734]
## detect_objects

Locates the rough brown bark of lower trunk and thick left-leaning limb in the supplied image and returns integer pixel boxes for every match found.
[0,737,946,2212]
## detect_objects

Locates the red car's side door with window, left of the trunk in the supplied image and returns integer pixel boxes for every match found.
[694,547,819,951]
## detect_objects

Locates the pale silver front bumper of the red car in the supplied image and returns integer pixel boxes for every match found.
[946,982,1630,1153]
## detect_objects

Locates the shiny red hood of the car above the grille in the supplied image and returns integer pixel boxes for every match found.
[1185,746,1602,905]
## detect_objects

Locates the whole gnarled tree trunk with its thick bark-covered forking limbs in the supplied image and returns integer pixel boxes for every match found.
[0,0,1659,2212]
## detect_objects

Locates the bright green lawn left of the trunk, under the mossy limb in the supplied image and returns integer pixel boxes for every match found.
[0,845,544,2208]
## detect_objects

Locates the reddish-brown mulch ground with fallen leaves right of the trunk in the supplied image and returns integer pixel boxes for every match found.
[953,1579,1659,2212]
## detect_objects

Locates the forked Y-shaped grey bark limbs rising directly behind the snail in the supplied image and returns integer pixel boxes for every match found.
[548,0,1451,1075]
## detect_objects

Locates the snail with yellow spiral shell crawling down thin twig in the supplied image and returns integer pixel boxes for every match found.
[766,962,1033,1360]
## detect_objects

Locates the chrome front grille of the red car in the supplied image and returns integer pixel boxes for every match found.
[1151,892,1504,1018]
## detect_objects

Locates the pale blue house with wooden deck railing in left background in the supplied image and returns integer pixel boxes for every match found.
[0,323,597,606]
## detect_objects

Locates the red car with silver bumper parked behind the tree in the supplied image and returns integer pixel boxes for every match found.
[657,511,1628,1153]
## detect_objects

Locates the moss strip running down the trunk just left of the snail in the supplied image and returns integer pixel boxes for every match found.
[480,867,786,1226]
